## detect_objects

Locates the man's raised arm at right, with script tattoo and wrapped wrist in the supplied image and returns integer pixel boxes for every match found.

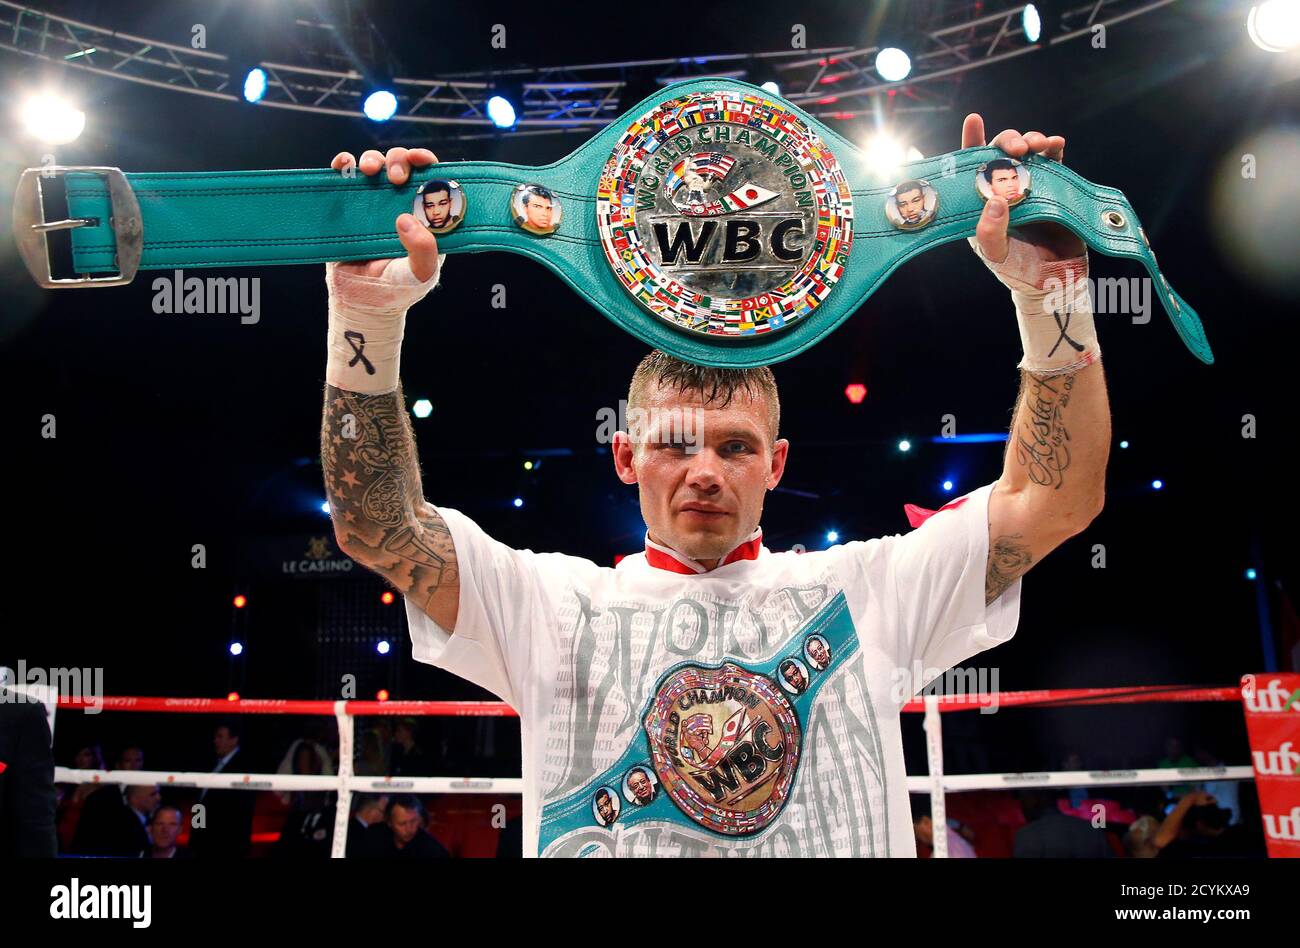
[962,114,1110,602]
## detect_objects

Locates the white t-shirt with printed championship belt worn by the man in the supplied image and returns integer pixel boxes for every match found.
[407,475,1021,857]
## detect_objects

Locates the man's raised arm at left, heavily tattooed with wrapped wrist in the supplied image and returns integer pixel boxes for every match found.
[321,148,460,632]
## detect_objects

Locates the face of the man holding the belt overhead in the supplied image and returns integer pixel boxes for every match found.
[614,384,789,564]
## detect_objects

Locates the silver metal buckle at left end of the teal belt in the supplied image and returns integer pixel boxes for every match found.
[13,165,144,290]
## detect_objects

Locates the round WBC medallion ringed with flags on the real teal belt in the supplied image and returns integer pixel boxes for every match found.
[595,90,853,338]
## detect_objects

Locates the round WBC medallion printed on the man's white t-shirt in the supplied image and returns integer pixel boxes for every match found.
[645,662,801,836]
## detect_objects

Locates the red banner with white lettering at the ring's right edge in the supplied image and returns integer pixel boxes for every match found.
[1242,672,1300,858]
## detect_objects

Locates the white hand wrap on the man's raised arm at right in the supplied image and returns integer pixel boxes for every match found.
[967,237,1101,376]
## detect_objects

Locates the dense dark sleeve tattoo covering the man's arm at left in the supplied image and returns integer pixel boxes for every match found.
[321,385,456,605]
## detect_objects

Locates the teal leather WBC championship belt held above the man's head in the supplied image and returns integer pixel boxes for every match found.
[14,78,1214,368]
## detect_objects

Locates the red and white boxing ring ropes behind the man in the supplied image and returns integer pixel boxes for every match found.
[55,685,1255,858]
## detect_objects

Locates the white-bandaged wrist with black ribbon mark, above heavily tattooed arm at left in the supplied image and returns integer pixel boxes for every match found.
[325,254,446,394]
